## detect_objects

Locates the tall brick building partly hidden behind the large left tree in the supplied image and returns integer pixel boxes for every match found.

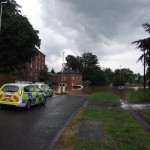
[26,50,45,81]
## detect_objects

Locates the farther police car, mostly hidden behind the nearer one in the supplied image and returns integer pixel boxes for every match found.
[35,83,54,97]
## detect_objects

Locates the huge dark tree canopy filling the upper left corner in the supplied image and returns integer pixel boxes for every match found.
[0,0,40,72]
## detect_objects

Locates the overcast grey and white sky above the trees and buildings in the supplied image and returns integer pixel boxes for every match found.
[16,0,150,74]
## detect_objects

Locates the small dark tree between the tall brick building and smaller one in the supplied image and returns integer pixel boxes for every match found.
[39,65,48,82]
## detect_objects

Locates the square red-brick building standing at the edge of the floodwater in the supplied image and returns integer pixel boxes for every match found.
[56,69,82,86]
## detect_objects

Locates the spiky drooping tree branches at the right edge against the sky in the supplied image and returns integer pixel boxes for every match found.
[133,23,150,73]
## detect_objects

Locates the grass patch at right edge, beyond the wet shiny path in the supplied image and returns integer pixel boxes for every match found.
[127,89,150,103]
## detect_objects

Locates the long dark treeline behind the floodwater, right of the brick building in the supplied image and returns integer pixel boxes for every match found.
[65,52,142,86]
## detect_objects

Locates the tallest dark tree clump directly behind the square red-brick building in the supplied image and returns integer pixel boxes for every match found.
[65,53,106,85]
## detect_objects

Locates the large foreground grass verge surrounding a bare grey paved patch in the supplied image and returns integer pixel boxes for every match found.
[55,108,150,150]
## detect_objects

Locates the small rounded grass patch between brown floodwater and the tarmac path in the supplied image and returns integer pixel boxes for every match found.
[89,92,119,102]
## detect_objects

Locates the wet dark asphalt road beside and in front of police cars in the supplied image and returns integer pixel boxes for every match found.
[0,95,84,150]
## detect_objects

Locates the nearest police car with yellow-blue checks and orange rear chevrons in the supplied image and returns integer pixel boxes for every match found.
[0,83,46,109]
